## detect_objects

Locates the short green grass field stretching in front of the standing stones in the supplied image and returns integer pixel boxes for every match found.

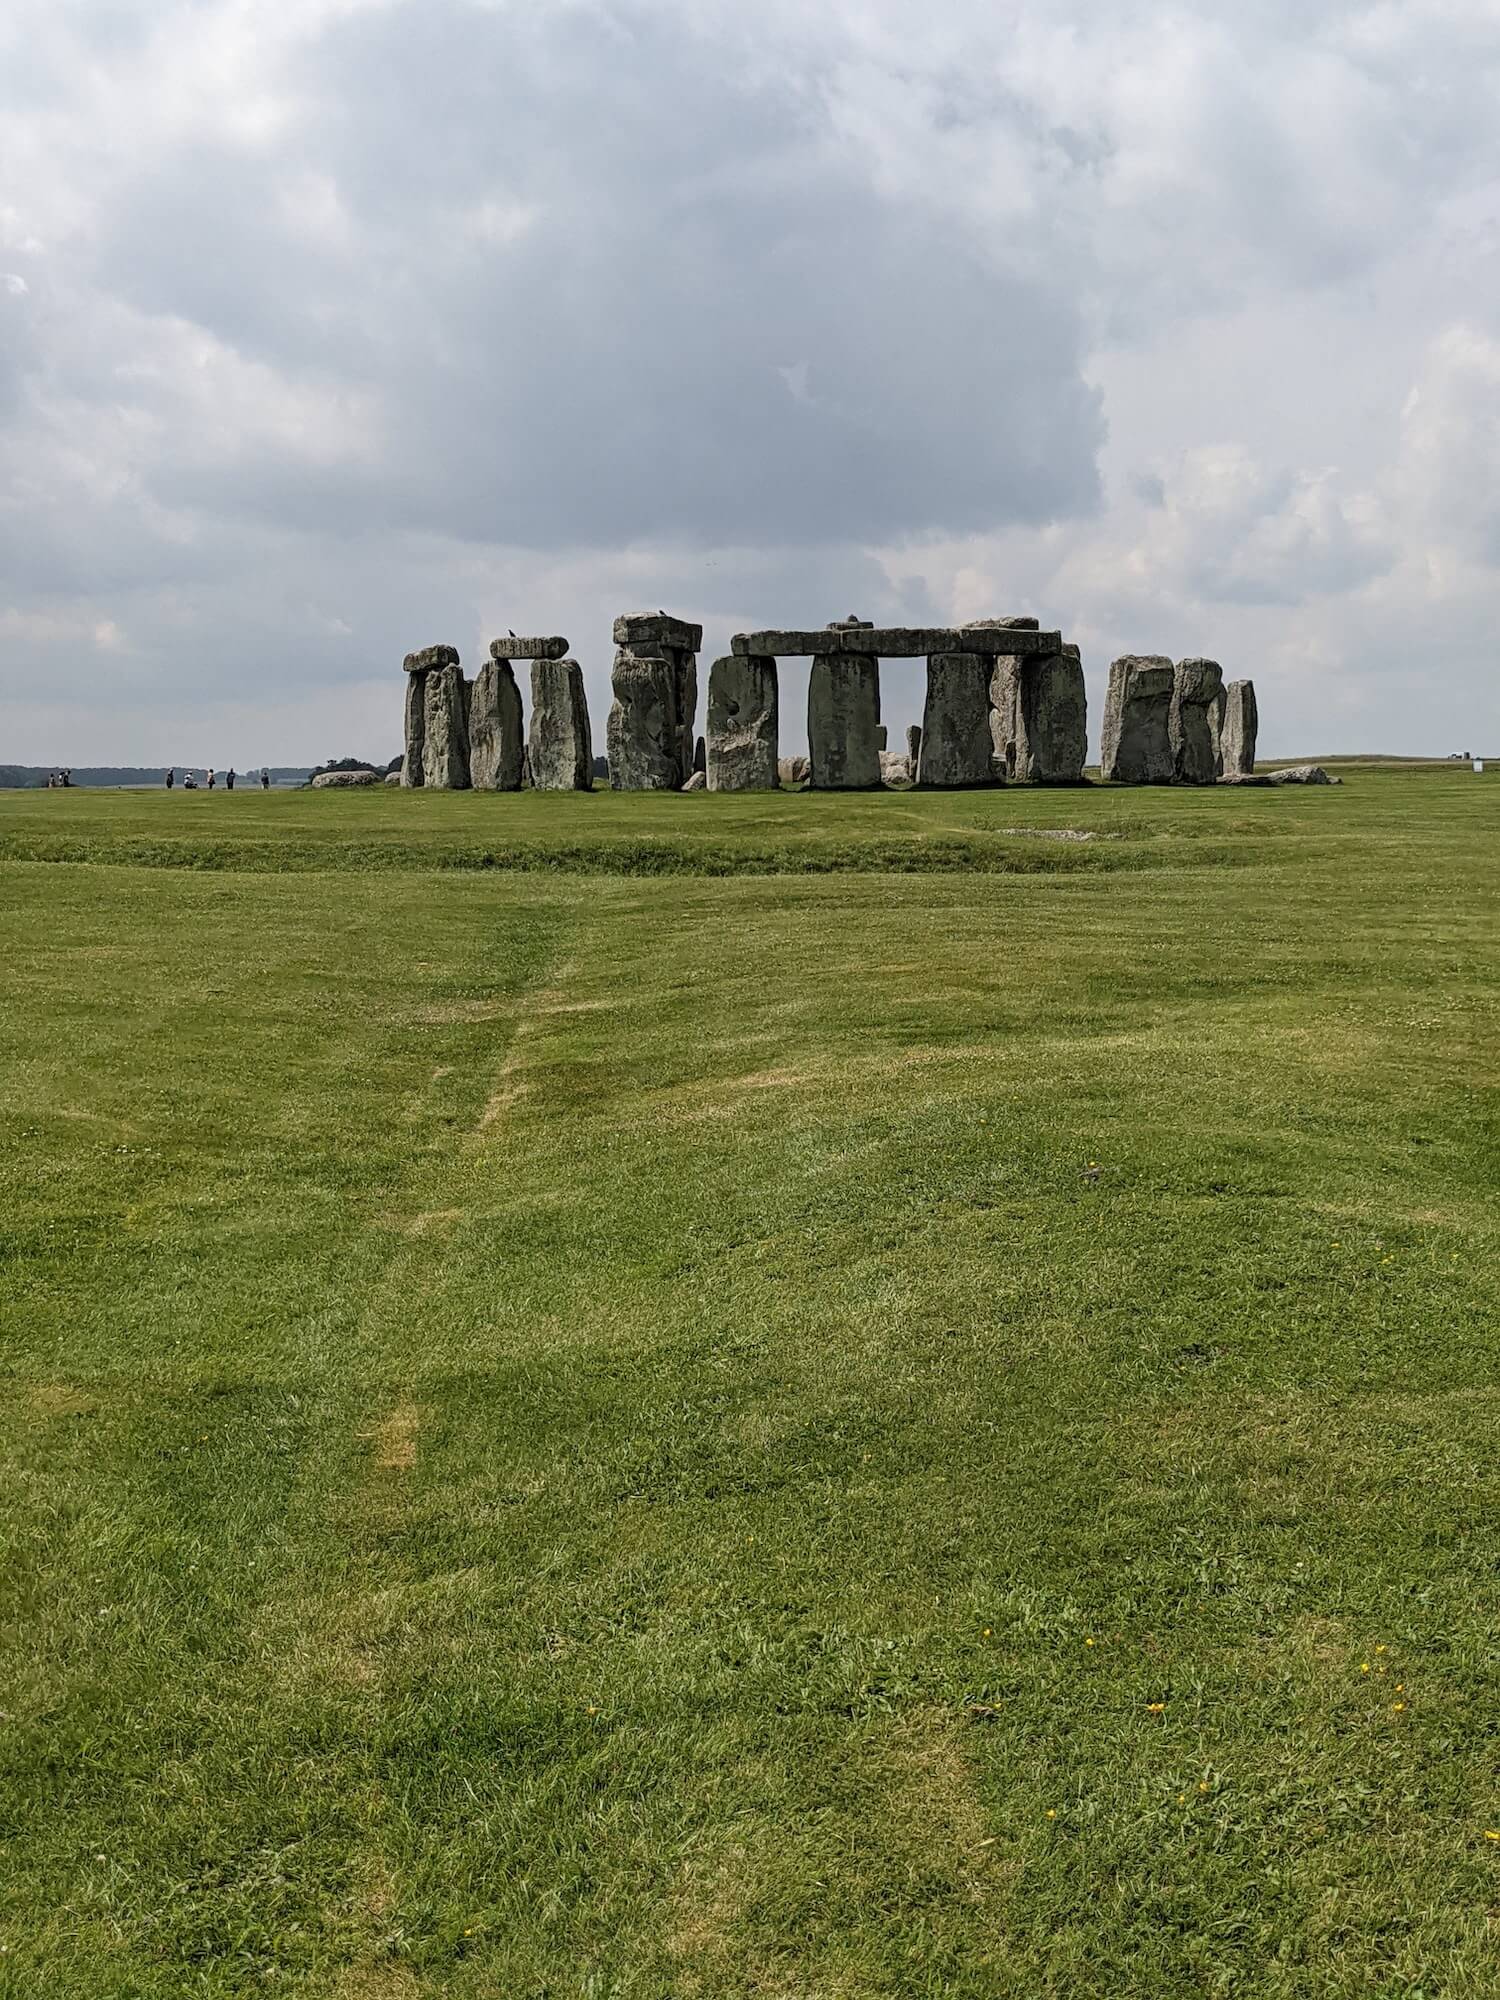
[0,770,1500,2000]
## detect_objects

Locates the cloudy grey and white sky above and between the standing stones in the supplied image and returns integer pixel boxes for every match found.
[0,0,1500,766]
